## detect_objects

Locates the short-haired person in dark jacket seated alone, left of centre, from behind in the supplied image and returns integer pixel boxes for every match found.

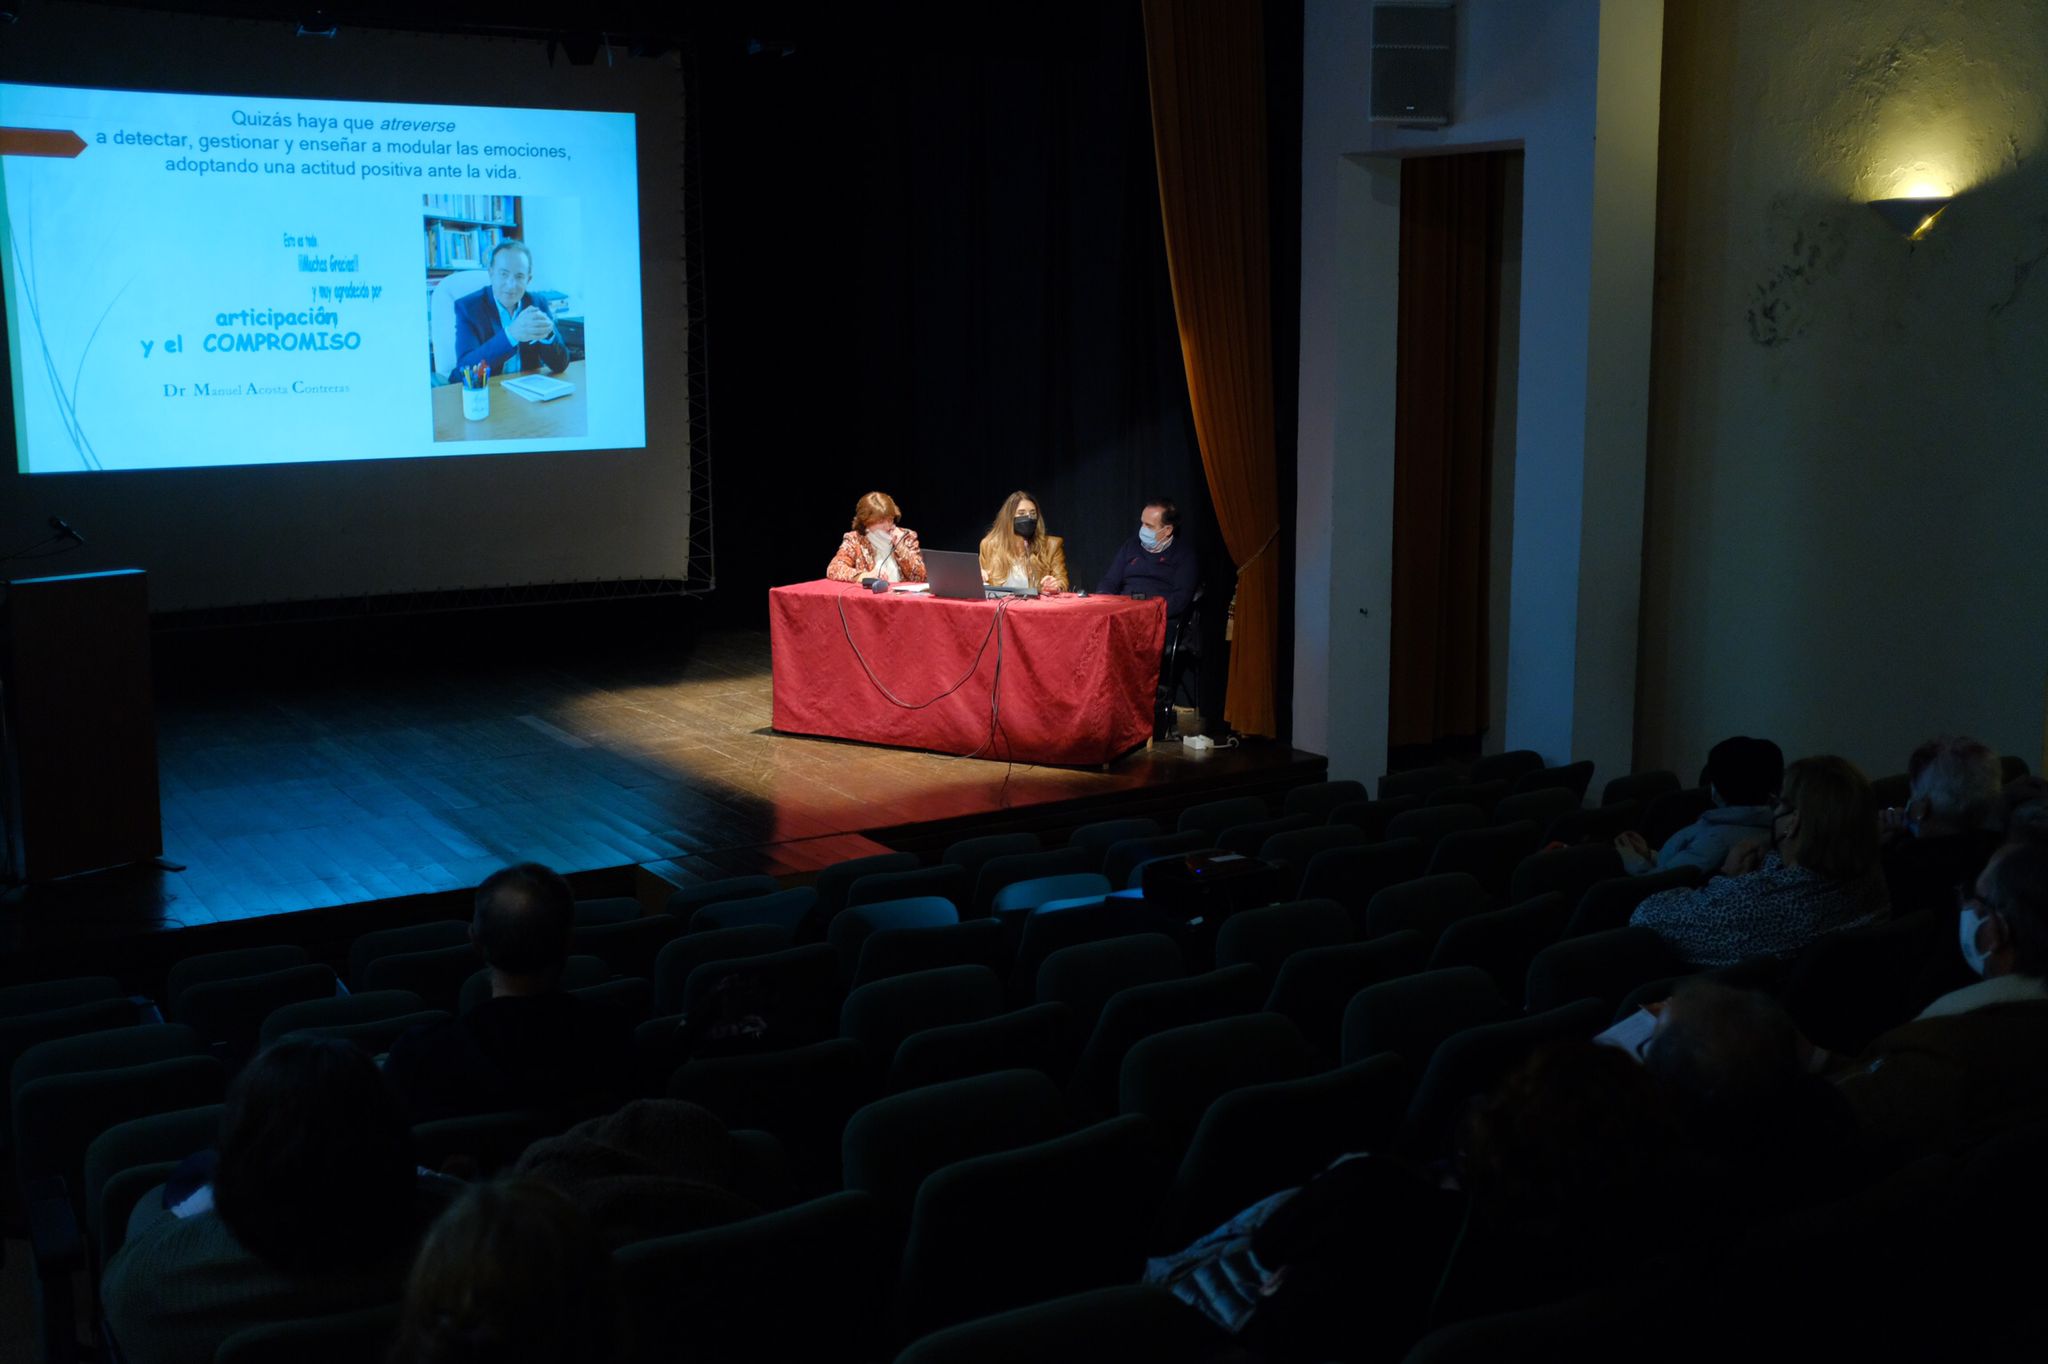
[385,862,633,1122]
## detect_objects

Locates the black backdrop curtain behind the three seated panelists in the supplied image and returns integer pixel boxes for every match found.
[700,4,1231,713]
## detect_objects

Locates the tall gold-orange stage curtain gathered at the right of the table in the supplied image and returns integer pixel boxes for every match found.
[1143,0,1284,735]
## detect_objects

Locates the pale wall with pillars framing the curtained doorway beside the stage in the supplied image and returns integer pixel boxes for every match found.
[1294,0,1663,778]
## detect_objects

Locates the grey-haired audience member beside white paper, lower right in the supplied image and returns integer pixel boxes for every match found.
[1642,979,1864,1225]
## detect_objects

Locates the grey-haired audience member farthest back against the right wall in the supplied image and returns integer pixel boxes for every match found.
[1880,739,2005,915]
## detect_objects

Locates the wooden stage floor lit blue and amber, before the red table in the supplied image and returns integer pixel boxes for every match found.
[0,631,1325,979]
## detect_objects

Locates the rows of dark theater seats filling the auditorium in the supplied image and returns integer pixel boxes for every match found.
[0,764,1966,1364]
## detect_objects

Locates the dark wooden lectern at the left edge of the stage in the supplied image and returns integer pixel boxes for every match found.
[0,569,164,881]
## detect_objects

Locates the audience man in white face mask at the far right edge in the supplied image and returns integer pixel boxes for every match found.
[1839,838,2048,1161]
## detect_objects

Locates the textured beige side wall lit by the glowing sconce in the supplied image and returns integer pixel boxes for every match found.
[1636,0,2048,774]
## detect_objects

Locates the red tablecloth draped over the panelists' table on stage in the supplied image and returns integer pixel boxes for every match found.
[768,582,1165,766]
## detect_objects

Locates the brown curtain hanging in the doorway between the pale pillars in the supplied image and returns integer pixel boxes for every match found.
[1386,152,1507,748]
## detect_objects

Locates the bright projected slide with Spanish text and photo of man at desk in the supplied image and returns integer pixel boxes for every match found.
[0,84,643,473]
